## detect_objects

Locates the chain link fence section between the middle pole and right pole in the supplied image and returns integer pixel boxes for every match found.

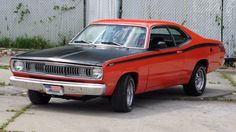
[122,0,221,40]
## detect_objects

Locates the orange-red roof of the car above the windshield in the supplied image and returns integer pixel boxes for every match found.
[92,19,180,27]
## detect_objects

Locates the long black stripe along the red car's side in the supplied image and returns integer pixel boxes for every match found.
[108,43,219,66]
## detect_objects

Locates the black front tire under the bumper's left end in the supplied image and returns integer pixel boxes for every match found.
[28,90,51,105]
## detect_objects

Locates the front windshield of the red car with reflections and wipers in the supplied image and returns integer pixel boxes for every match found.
[72,25,146,48]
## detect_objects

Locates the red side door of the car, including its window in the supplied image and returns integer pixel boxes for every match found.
[147,26,187,91]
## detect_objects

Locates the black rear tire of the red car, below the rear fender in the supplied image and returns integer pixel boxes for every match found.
[184,64,207,96]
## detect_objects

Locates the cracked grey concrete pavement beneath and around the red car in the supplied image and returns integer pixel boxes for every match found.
[0,68,236,132]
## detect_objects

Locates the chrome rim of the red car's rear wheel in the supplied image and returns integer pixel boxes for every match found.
[195,68,205,91]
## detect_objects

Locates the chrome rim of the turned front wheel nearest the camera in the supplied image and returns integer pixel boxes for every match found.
[127,80,134,107]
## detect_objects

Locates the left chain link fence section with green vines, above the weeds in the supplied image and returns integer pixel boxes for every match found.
[0,0,84,42]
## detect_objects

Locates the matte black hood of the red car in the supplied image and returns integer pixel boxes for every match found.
[13,46,145,66]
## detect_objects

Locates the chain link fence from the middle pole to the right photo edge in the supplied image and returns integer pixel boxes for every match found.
[122,0,236,58]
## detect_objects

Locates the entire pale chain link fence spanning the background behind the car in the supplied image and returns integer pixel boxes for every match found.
[0,0,236,58]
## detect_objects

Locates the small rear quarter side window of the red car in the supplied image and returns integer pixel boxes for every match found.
[169,27,189,46]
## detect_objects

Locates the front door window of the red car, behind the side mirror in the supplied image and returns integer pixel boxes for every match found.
[149,27,175,49]
